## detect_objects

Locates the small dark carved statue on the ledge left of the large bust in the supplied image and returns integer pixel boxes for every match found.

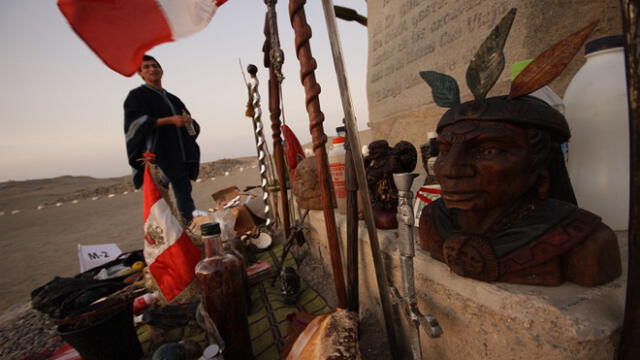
[364,140,418,229]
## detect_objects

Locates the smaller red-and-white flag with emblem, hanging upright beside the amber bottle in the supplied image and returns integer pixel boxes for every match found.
[142,160,201,301]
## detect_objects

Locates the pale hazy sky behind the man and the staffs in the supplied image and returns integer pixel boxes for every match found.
[0,0,368,181]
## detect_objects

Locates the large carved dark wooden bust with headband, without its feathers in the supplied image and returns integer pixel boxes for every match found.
[420,96,621,286]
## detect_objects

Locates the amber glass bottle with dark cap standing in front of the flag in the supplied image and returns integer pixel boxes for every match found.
[196,223,253,360]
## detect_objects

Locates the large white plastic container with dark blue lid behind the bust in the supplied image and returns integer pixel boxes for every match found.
[564,36,629,230]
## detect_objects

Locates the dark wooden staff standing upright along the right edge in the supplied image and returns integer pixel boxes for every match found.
[618,0,640,360]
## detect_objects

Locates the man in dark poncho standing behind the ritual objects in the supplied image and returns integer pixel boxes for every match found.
[124,55,200,224]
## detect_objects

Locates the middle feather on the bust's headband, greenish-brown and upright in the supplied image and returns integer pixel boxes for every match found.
[467,8,516,100]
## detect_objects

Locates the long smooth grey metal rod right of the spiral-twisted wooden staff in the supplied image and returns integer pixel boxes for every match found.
[322,0,398,358]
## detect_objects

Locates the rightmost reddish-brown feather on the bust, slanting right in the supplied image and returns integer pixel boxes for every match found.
[509,21,598,99]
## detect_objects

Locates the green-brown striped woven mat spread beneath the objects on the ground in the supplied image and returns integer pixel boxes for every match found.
[138,244,333,360]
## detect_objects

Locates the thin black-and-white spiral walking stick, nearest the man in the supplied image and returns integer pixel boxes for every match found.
[247,65,271,227]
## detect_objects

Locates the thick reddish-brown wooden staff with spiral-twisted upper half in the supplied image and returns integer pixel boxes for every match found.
[289,0,348,309]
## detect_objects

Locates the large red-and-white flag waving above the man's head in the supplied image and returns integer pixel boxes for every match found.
[58,0,227,76]
